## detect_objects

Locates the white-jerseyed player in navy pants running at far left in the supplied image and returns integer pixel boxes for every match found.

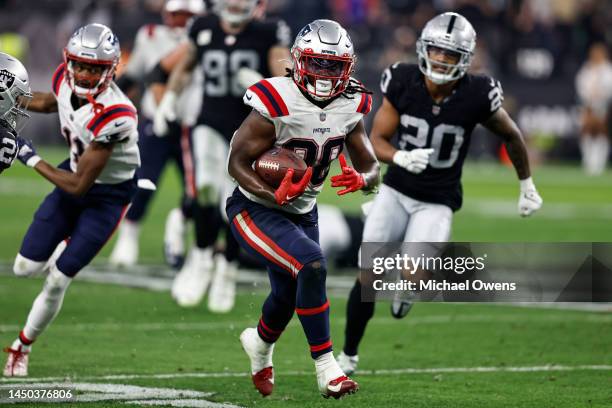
[4,24,140,377]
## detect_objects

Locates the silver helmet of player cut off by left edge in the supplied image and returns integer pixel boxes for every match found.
[0,52,32,132]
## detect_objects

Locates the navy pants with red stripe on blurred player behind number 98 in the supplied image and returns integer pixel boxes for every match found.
[126,118,195,222]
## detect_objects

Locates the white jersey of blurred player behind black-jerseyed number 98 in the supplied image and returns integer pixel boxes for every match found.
[125,24,202,125]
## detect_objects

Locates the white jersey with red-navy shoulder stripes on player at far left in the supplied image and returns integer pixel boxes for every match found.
[53,64,140,184]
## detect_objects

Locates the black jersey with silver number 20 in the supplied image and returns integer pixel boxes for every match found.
[380,63,503,211]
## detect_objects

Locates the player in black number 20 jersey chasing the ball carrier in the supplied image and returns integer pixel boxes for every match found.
[338,13,542,373]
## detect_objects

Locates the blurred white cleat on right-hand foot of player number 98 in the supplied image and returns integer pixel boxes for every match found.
[208,254,238,313]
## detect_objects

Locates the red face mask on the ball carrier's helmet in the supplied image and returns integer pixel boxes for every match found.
[294,53,353,100]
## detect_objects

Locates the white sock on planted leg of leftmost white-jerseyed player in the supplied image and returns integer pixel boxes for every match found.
[23,265,72,341]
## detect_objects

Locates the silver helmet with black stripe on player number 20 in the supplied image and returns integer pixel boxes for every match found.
[416,13,476,84]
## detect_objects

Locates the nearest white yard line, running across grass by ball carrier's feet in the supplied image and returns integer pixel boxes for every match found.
[0,364,612,385]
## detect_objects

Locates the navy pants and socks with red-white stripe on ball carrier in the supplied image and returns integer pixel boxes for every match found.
[226,189,332,358]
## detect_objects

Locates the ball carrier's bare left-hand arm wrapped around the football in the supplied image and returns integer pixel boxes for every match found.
[227,110,276,203]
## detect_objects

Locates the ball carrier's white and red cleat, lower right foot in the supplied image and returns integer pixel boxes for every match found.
[315,351,359,399]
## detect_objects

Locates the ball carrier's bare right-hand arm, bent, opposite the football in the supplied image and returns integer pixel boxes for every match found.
[332,120,380,194]
